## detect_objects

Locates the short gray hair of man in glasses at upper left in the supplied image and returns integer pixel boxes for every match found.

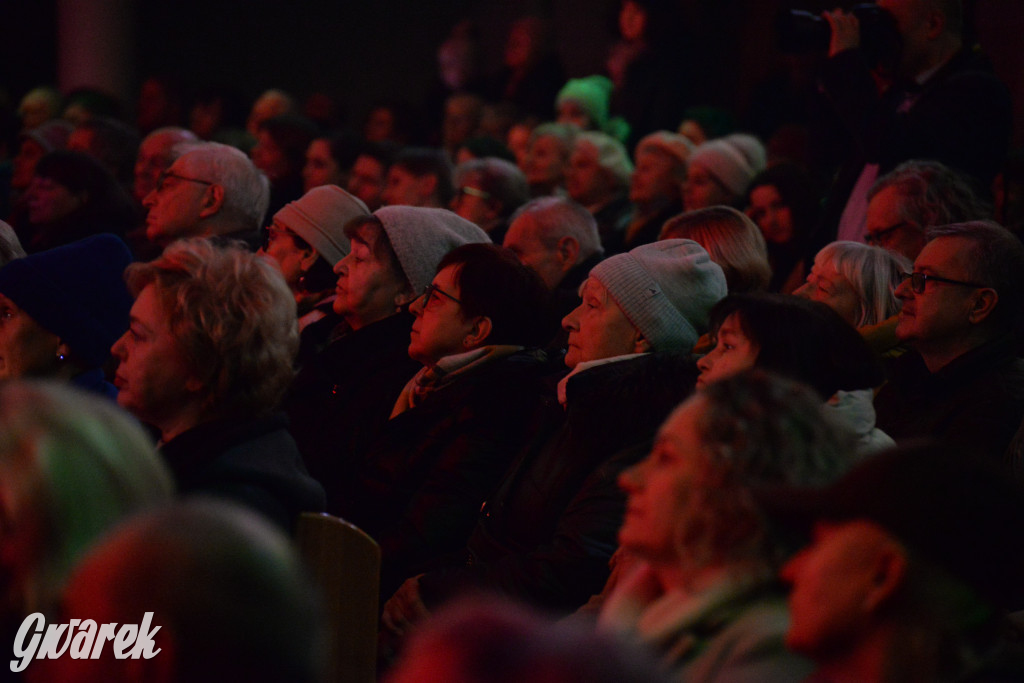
[175,142,270,234]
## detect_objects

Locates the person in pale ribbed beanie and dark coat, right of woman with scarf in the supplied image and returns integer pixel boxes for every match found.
[383,240,726,635]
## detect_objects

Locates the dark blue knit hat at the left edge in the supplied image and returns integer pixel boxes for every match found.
[0,234,132,368]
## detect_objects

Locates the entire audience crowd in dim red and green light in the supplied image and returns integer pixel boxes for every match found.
[0,0,1024,683]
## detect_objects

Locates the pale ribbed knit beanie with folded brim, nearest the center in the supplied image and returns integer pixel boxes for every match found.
[590,240,727,352]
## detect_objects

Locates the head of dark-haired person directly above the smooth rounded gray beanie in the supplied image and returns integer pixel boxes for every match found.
[381,147,453,209]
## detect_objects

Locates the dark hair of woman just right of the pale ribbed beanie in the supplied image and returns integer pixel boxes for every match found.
[711,293,885,399]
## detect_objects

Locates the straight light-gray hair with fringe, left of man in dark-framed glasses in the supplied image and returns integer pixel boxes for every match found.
[814,242,913,328]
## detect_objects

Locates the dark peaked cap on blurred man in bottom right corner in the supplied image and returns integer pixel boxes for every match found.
[758,440,1024,608]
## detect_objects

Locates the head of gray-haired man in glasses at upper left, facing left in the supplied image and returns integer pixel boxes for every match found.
[142,142,270,249]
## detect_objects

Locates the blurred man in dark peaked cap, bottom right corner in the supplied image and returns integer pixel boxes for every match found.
[761,442,1024,683]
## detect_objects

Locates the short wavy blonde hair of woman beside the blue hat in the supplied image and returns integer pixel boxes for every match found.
[125,240,299,417]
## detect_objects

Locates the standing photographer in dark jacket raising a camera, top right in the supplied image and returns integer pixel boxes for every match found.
[821,0,1012,242]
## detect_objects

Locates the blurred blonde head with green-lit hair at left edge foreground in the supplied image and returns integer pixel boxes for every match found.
[0,381,173,643]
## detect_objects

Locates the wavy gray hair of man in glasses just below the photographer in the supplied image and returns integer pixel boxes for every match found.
[867,160,992,227]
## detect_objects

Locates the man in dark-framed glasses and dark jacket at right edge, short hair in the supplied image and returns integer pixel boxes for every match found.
[874,221,1024,481]
